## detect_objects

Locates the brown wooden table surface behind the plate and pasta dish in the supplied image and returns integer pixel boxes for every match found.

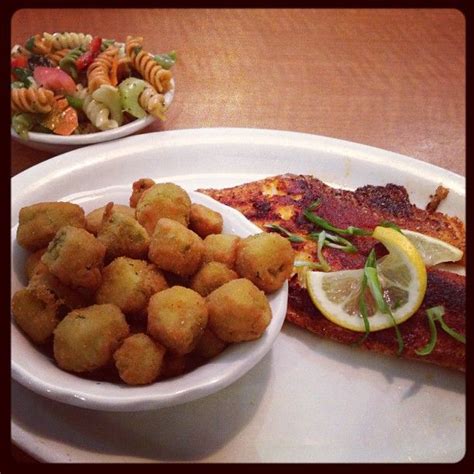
[11,9,466,461]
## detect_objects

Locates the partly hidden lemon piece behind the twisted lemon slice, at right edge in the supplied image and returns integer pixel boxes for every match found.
[402,229,463,267]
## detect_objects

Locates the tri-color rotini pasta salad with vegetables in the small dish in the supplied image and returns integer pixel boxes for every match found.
[10,32,176,138]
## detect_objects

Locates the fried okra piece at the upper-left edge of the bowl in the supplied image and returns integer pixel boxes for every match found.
[16,202,86,252]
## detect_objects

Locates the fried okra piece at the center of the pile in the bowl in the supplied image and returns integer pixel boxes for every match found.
[96,257,168,314]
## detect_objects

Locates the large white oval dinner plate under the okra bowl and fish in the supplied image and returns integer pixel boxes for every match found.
[11,128,466,463]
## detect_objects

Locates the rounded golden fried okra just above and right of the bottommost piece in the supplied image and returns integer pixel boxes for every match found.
[147,286,208,355]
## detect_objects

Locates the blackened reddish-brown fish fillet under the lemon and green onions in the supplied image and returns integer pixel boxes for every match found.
[199,174,466,371]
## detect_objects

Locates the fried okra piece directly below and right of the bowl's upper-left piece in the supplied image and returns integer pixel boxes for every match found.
[41,226,106,290]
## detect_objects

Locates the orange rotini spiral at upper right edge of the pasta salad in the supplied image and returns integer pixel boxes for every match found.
[125,36,172,93]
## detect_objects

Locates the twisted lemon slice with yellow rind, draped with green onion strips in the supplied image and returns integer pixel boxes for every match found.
[306,227,426,332]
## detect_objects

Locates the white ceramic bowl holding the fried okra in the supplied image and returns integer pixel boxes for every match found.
[11,189,288,411]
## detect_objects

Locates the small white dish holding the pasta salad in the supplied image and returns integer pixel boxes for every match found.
[10,73,175,154]
